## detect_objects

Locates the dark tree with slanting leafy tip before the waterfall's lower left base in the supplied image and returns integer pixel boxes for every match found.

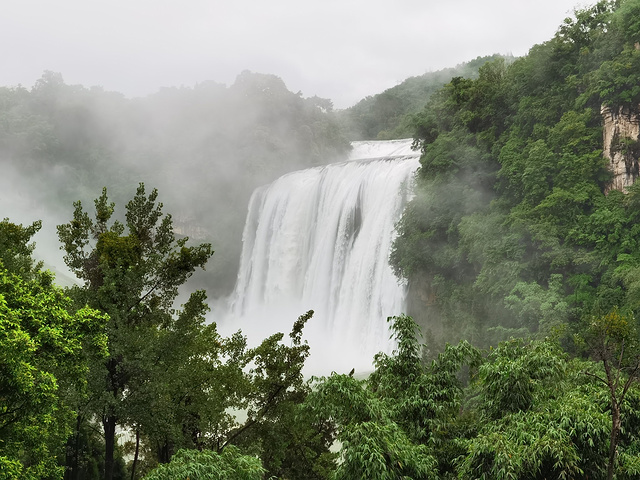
[218,310,334,479]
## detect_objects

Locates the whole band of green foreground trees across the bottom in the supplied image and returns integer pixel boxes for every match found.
[0,207,640,480]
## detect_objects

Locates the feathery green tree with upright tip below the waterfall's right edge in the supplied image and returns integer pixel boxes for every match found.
[306,315,479,479]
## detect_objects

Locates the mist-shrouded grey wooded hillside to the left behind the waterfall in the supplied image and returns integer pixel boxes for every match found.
[0,71,350,295]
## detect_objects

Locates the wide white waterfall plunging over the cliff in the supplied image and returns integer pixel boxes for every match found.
[226,140,419,374]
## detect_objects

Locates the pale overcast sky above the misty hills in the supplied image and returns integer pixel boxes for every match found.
[0,0,593,108]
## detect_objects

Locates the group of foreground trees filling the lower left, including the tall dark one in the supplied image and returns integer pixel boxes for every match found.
[0,196,324,480]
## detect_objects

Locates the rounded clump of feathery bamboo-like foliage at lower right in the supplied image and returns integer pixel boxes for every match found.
[458,339,608,480]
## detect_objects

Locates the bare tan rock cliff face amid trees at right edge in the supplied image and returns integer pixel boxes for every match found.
[601,106,640,193]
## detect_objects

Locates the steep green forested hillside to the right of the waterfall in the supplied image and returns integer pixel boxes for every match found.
[391,1,640,346]
